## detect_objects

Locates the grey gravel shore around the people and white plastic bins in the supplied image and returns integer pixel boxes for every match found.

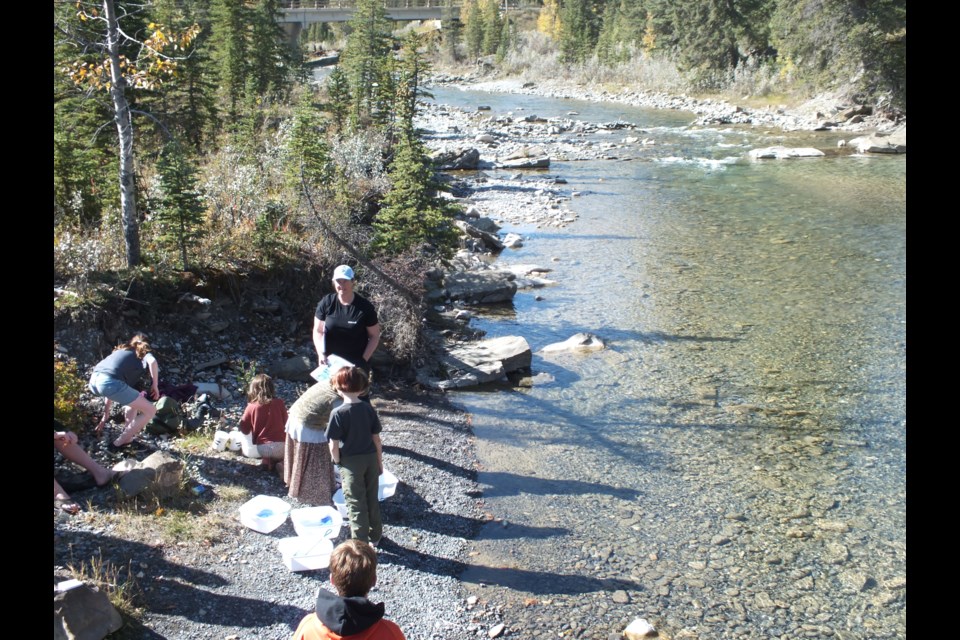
[54,332,495,640]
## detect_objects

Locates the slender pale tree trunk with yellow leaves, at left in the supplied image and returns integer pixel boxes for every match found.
[103,0,140,267]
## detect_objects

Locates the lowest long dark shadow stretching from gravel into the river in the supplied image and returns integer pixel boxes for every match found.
[378,543,643,595]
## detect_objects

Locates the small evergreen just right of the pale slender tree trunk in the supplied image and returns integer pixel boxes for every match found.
[156,142,205,271]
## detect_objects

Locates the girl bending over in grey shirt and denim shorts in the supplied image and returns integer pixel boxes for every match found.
[88,333,160,449]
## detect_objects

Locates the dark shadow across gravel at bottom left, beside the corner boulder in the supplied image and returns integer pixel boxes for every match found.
[54,531,307,638]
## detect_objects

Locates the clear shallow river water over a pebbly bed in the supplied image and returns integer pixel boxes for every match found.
[434,89,906,638]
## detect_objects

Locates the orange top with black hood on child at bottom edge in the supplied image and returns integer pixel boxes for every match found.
[293,589,404,640]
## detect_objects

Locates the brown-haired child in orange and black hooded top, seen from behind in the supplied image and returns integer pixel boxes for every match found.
[292,540,406,640]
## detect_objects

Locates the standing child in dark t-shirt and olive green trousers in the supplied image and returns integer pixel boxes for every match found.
[327,367,383,546]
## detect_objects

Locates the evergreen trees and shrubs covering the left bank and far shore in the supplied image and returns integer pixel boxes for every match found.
[53,0,906,370]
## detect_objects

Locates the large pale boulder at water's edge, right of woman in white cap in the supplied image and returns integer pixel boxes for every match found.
[432,336,533,389]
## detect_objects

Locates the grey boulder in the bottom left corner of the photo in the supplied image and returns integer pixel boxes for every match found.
[53,580,123,640]
